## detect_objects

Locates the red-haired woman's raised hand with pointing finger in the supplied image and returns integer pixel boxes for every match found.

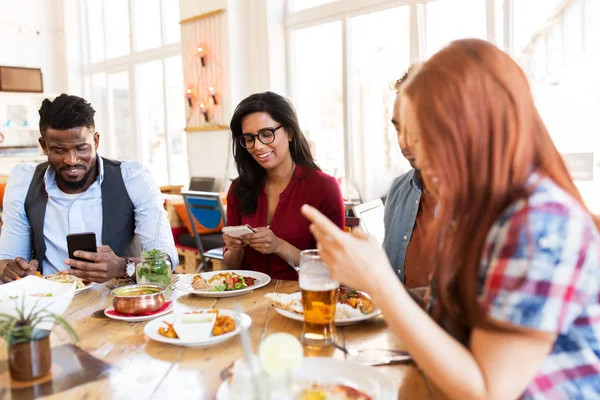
[302,205,397,292]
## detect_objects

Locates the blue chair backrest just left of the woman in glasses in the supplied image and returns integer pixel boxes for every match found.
[181,191,226,268]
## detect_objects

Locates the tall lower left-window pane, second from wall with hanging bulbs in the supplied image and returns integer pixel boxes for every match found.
[136,60,169,185]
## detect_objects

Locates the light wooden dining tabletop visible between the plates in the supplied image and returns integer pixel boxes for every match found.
[0,281,438,400]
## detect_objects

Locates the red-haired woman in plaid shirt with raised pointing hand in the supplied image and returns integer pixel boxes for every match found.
[303,39,600,399]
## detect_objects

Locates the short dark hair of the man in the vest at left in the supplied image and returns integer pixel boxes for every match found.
[39,93,96,136]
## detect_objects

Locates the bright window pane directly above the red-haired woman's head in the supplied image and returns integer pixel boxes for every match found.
[425,0,487,58]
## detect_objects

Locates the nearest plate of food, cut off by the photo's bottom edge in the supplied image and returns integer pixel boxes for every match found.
[217,357,398,400]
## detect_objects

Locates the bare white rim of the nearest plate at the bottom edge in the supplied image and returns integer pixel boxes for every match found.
[217,357,398,400]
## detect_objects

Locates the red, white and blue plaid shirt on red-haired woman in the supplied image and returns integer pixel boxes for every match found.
[479,174,600,400]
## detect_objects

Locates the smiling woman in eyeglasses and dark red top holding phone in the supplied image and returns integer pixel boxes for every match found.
[223,92,344,280]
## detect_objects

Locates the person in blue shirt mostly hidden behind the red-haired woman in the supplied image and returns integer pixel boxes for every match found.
[383,66,437,295]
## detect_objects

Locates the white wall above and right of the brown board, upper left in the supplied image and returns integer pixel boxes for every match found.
[0,0,67,94]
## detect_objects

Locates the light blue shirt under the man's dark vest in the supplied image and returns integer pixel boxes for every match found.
[0,157,179,275]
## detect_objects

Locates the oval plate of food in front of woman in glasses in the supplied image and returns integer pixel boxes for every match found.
[175,270,271,297]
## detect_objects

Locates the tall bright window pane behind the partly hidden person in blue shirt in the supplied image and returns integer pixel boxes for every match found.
[349,6,410,201]
